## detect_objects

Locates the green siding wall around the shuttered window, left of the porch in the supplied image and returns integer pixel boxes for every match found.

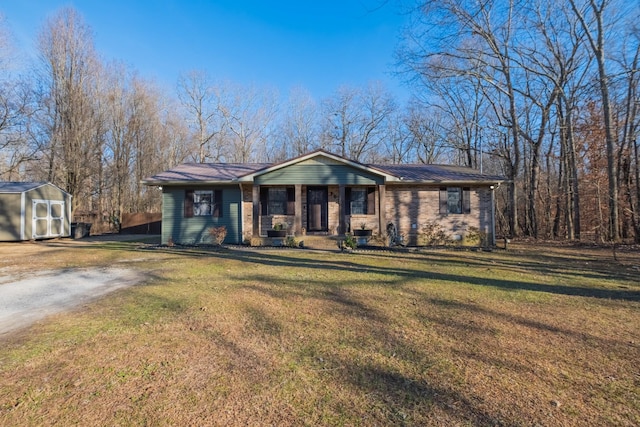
[162,185,242,244]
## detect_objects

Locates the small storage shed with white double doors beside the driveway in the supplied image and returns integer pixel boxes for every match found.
[0,182,71,242]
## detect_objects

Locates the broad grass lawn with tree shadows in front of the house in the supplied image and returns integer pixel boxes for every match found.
[0,243,640,426]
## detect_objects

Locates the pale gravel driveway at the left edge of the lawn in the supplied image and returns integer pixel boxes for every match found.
[0,268,143,336]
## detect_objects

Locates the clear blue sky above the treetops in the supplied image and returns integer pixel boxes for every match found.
[0,0,405,99]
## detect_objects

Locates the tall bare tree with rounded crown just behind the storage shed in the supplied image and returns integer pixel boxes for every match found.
[38,8,100,208]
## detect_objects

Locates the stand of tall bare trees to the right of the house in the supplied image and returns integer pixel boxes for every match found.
[398,0,640,241]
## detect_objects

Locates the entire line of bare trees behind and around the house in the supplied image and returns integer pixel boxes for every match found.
[0,0,640,241]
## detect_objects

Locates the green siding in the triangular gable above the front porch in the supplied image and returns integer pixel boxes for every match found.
[255,163,384,185]
